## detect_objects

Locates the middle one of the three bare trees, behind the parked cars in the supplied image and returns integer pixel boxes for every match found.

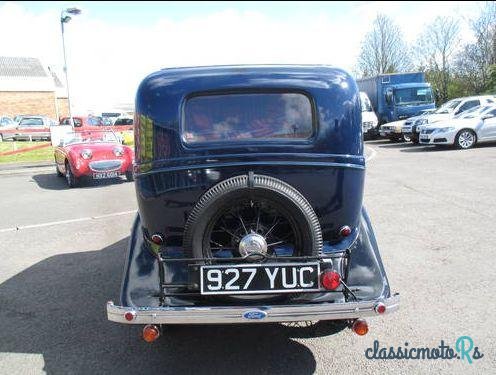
[415,17,460,103]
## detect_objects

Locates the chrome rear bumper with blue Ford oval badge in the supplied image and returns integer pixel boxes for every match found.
[107,294,400,324]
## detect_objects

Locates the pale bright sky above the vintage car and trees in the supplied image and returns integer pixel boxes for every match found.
[0,1,484,114]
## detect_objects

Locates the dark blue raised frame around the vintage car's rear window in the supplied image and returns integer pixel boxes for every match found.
[179,88,318,149]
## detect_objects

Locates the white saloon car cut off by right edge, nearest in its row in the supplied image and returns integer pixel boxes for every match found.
[420,105,496,149]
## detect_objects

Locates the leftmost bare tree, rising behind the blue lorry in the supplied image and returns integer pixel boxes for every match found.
[357,14,411,77]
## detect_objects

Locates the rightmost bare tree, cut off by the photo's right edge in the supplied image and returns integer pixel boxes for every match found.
[456,1,496,93]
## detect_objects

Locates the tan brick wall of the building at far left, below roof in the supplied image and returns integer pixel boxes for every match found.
[0,91,58,120]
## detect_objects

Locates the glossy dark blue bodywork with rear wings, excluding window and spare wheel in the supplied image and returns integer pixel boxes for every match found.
[121,66,390,308]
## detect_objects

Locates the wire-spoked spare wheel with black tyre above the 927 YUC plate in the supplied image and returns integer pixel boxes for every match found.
[183,172,322,261]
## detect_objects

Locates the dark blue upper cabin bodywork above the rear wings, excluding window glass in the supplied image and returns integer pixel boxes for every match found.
[135,66,365,245]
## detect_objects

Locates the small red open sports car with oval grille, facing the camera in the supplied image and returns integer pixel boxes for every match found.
[55,131,134,188]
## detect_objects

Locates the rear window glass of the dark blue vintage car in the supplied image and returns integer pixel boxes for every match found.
[183,93,313,143]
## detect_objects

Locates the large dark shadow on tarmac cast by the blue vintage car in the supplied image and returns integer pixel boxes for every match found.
[0,239,322,374]
